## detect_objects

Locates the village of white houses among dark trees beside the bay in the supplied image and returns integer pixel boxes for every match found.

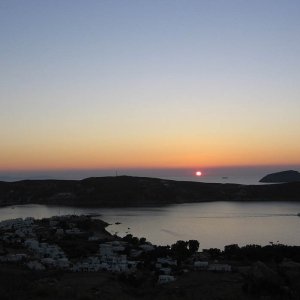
[0,215,231,284]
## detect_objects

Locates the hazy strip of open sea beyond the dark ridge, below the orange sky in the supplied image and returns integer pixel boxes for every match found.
[0,165,300,184]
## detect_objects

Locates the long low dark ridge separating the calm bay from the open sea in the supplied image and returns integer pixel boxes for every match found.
[0,176,300,207]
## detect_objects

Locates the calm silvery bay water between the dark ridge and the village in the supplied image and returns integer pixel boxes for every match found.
[0,202,300,249]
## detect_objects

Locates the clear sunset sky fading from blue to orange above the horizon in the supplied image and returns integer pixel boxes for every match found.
[0,0,300,170]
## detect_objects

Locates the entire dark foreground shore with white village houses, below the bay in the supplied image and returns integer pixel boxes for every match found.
[0,215,300,299]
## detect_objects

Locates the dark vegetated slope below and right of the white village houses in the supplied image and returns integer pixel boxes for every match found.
[0,239,300,300]
